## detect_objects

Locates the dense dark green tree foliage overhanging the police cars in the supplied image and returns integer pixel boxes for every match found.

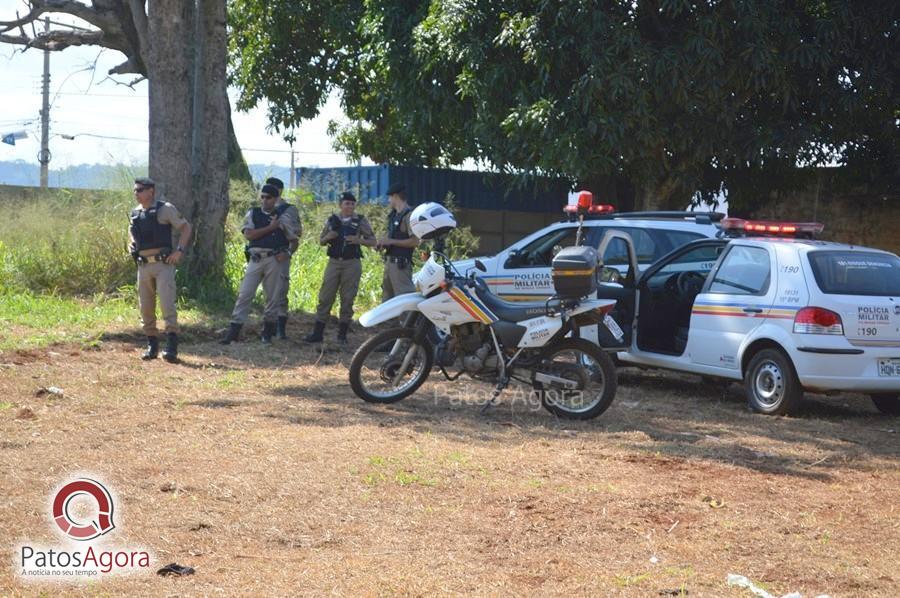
[230,0,900,207]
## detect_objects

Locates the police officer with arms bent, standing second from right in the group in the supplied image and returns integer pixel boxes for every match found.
[303,191,375,344]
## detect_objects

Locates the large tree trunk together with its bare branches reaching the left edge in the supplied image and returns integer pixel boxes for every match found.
[0,0,239,278]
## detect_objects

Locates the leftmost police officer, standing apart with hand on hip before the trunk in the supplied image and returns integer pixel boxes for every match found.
[128,178,191,363]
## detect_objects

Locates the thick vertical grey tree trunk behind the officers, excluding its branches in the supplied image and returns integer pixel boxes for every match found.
[147,0,230,279]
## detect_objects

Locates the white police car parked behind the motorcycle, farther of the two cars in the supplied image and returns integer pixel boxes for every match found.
[456,198,724,301]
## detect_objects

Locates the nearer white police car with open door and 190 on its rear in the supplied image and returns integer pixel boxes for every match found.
[599,218,900,414]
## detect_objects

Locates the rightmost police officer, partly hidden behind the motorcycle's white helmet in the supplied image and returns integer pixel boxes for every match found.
[378,184,419,301]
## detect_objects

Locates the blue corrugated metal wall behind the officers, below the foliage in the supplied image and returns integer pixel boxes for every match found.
[297,164,569,213]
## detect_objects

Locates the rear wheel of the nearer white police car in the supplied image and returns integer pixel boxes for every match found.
[744,349,803,415]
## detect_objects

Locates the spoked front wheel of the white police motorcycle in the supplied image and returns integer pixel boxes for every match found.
[350,328,434,403]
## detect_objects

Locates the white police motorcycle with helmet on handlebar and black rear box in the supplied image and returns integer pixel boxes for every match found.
[350,203,617,419]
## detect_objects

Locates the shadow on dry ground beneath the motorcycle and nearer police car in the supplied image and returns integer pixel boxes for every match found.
[266,370,900,480]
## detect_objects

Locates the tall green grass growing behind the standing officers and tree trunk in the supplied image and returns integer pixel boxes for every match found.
[0,183,477,318]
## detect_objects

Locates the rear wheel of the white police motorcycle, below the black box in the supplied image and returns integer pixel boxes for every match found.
[532,338,617,419]
